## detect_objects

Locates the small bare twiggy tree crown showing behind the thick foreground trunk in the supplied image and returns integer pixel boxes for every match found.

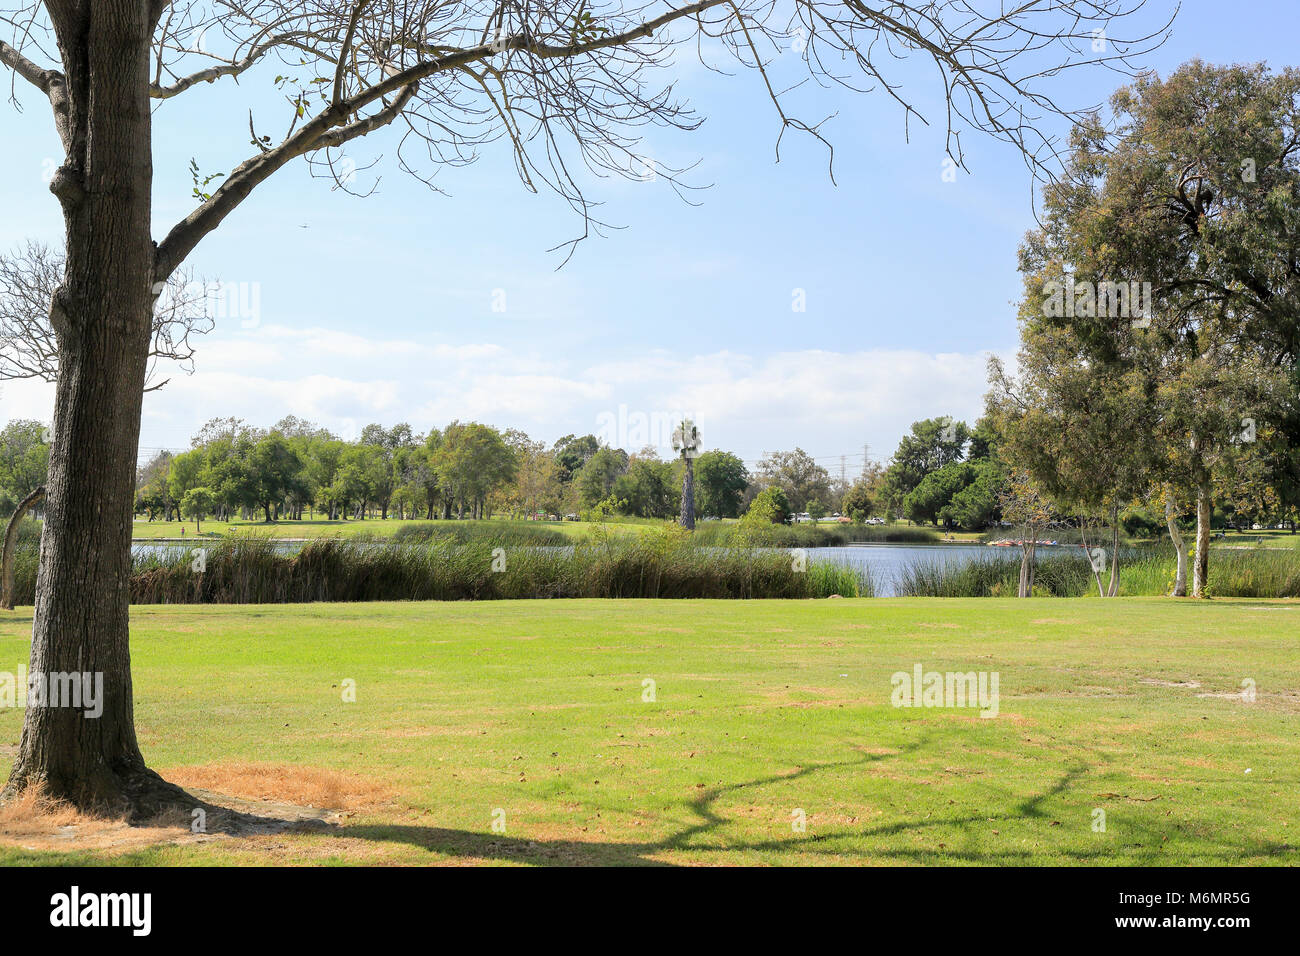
[0,242,216,392]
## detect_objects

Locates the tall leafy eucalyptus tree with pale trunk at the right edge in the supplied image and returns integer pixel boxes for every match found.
[1021,61,1300,596]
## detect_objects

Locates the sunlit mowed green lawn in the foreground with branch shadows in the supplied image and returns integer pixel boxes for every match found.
[0,598,1300,865]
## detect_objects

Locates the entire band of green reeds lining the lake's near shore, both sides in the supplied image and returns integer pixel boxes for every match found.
[5,520,1300,605]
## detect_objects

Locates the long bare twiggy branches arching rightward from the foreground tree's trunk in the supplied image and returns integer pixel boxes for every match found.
[137,0,1169,278]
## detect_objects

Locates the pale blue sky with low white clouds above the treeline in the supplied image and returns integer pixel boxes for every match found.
[0,0,1300,472]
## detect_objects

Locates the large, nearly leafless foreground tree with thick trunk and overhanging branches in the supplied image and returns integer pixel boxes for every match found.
[0,0,1167,813]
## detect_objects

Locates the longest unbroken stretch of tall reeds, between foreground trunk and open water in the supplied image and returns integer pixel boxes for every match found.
[116,527,872,604]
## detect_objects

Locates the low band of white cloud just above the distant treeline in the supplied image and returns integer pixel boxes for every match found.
[10,325,987,460]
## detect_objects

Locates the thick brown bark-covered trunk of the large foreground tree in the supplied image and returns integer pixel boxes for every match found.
[5,0,183,817]
